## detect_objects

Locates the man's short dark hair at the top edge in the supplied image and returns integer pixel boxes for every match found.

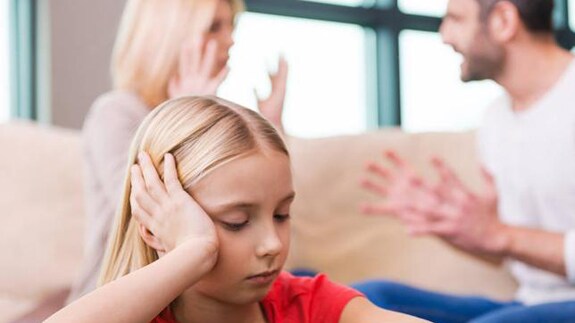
[477,0,553,33]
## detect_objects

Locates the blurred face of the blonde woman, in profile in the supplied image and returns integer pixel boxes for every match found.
[206,0,234,71]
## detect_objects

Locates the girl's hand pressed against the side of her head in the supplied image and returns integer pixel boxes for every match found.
[130,152,218,258]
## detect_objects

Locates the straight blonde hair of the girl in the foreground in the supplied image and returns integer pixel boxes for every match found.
[100,97,288,285]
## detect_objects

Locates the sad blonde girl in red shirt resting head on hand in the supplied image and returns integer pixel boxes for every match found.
[47,97,428,323]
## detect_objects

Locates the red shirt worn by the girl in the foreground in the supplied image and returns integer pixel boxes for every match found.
[151,272,362,323]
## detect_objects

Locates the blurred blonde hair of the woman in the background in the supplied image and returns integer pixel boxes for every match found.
[111,0,244,107]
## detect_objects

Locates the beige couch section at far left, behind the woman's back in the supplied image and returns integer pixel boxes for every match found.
[0,122,85,299]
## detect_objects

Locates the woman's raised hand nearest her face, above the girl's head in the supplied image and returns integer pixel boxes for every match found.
[168,36,229,99]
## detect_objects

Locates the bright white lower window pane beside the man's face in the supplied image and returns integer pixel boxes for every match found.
[399,30,501,131]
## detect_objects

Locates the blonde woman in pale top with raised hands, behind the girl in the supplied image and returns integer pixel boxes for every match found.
[69,0,287,301]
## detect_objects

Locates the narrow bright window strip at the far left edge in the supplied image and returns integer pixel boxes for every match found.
[0,1,10,123]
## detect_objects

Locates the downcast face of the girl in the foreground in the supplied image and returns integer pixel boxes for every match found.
[192,150,294,305]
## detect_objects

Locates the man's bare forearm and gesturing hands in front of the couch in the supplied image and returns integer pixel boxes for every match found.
[363,153,575,276]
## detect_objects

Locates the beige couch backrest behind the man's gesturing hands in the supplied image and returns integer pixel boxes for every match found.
[289,129,516,299]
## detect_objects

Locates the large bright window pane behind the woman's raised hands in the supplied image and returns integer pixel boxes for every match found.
[218,12,367,137]
